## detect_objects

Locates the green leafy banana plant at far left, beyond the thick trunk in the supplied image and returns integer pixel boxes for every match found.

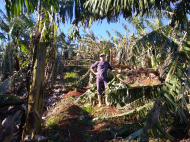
[0,11,33,79]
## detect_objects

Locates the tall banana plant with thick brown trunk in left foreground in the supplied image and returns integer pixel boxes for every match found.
[2,0,99,136]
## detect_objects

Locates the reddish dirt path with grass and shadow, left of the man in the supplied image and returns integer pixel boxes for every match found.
[43,74,126,142]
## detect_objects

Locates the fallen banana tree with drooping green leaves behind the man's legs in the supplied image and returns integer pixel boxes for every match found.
[77,73,163,107]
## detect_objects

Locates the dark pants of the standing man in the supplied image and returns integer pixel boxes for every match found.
[96,76,108,95]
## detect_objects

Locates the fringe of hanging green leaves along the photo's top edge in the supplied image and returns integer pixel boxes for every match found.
[5,0,190,26]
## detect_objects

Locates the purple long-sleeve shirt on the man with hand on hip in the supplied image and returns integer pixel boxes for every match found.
[90,61,113,78]
